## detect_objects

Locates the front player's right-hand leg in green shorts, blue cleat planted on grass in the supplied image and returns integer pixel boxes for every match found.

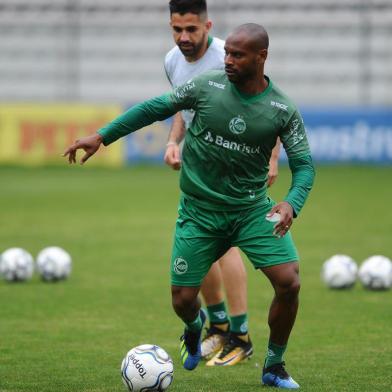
[233,201,299,389]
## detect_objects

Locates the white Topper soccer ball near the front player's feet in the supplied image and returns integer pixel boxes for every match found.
[121,344,173,392]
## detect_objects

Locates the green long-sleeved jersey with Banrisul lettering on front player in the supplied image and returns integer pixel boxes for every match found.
[98,71,313,213]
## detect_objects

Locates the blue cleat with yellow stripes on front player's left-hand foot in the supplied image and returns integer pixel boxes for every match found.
[180,309,207,370]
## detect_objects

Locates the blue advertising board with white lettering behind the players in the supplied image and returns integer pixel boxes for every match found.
[126,108,392,164]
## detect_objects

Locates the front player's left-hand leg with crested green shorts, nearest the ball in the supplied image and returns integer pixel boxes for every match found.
[171,199,228,370]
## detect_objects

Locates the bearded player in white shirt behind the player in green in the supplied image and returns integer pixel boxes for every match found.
[164,0,258,366]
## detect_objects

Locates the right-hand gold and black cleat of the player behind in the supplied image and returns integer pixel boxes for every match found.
[206,333,253,366]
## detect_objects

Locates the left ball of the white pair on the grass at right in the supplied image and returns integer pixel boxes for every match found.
[321,255,358,289]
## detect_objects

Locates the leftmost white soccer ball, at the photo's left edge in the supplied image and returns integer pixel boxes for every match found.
[0,248,34,282]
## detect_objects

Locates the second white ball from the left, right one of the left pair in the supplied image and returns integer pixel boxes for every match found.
[37,246,72,282]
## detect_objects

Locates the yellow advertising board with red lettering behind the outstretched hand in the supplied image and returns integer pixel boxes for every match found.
[0,104,124,166]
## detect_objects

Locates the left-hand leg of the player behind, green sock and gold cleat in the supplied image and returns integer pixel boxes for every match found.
[201,262,229,360]
